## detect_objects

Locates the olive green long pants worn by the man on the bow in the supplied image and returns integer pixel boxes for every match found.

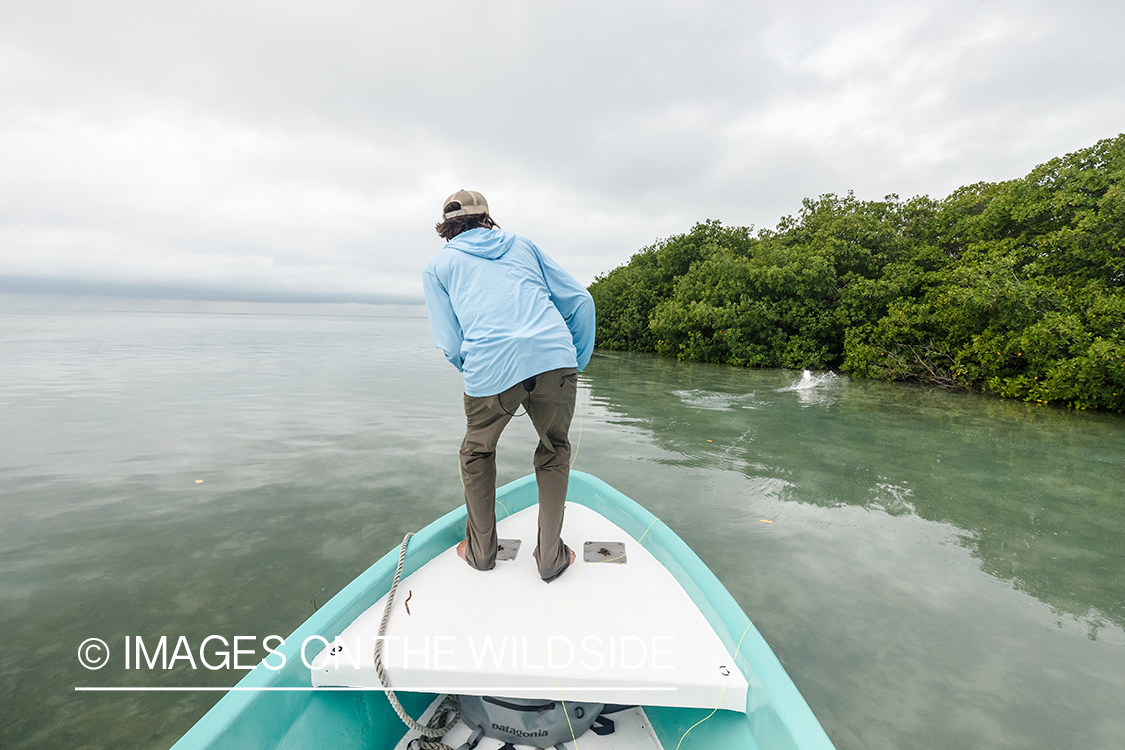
[460,368,578,579]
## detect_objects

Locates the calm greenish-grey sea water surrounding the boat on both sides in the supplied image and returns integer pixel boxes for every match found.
[0,313,1125,750]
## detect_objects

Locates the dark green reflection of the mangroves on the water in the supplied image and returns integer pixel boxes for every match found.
[587,354,1125,638]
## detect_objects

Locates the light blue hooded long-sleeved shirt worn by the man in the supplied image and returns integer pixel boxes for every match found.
[422,228,594,396]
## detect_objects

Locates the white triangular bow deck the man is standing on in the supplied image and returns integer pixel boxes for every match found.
[312,503,747,715]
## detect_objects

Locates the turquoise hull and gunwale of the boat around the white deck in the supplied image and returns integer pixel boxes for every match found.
[173,471,833,750]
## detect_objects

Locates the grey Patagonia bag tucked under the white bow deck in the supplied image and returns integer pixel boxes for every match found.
[459,695,604,748]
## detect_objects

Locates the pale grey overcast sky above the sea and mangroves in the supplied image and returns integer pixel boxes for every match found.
[0,0,1125,302]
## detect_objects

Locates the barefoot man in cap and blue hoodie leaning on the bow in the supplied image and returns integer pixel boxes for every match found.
[422,190,594,582]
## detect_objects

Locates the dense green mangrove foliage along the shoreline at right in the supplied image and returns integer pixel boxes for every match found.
[590,135,1125,412]
